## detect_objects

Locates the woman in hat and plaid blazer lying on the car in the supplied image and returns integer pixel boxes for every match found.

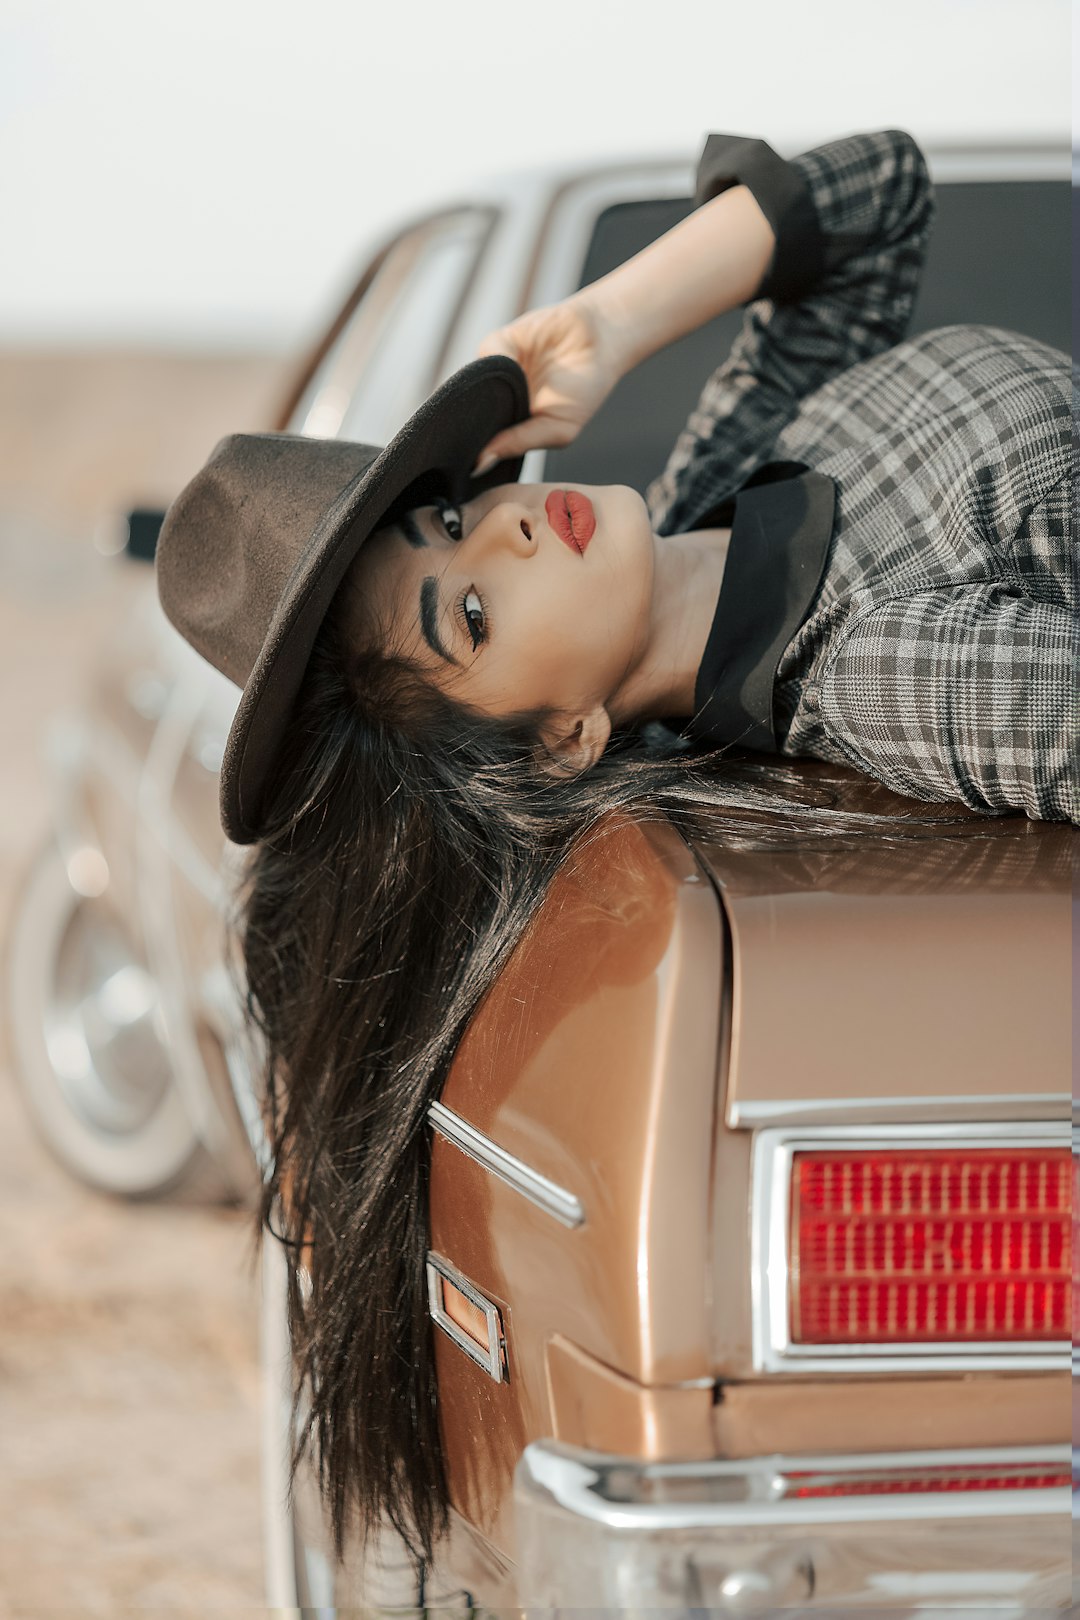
[159,131,1077,1581]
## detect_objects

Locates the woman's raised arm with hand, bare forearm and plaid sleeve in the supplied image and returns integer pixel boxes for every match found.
[479,130,934,533]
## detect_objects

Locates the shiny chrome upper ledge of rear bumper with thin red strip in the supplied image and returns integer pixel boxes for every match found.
[515,1440,1070,1531]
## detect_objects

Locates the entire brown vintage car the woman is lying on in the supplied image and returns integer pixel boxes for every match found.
[10,129,1075,1614]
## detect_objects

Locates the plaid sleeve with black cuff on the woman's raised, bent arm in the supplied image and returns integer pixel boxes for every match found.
[646,130,934,535]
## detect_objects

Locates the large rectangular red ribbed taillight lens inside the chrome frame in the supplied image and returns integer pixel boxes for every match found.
[790,1147,1072,1345]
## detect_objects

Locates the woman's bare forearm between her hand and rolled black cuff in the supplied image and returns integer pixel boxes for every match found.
[575,185,776,376]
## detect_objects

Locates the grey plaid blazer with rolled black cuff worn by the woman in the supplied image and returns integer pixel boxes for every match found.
[646,130,1080,821]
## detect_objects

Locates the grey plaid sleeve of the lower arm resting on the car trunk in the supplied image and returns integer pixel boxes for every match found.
[818,583,1080,821]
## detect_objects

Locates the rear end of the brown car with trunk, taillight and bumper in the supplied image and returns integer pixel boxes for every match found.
[404,770,1074,1607]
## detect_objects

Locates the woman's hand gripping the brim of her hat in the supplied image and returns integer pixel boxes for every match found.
[473,288,625,478]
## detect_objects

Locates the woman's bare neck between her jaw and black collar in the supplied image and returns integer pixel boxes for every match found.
[609,528,732,724]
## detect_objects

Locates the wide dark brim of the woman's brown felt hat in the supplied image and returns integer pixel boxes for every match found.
[220,355,529,844]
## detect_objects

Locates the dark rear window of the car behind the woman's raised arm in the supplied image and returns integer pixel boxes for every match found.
[538,180,1072,494]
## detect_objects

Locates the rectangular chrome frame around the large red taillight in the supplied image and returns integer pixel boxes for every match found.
[750,1119,1069,1377]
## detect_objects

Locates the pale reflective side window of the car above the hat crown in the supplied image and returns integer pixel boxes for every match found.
[290,209,491,444]
